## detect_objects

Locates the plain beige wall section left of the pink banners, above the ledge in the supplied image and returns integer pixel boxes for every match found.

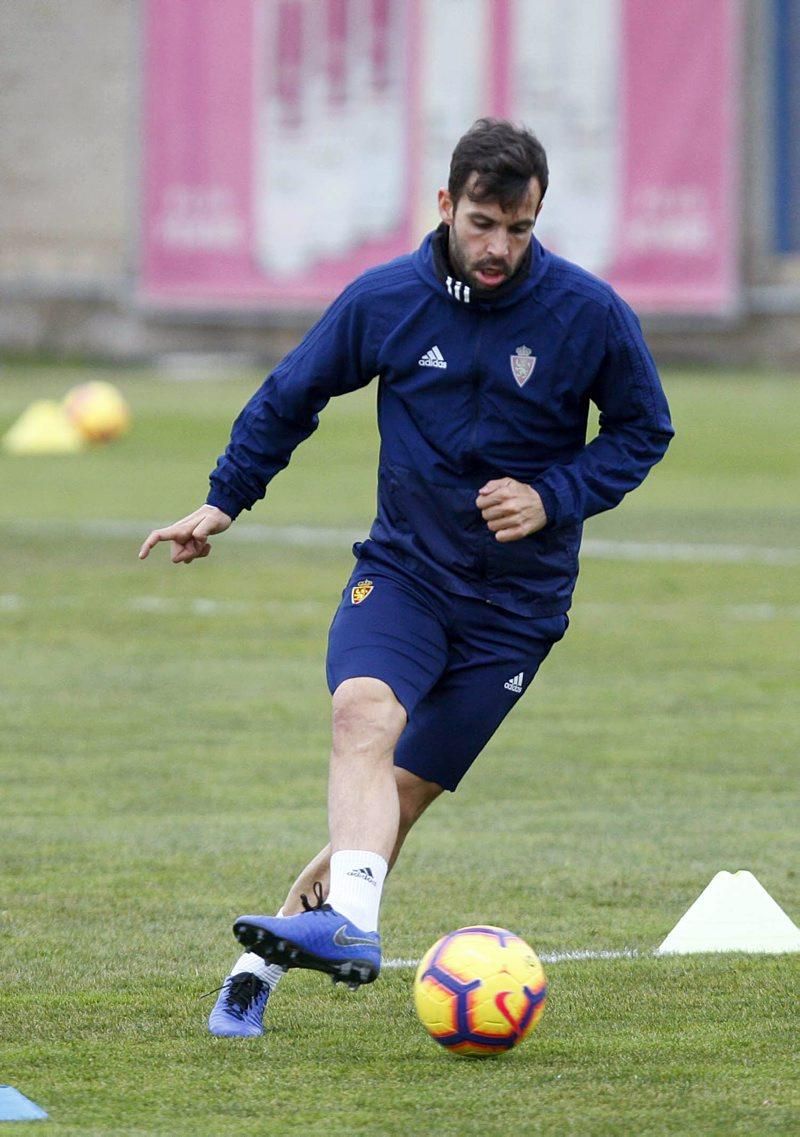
[0,0,138,293]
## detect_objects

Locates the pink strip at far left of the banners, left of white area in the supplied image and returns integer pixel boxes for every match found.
[142,0,252,298]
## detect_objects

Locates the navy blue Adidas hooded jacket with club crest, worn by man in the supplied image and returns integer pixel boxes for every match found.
[208,227,673,616]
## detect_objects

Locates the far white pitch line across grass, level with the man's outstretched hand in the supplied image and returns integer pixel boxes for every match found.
[5,518,800,566]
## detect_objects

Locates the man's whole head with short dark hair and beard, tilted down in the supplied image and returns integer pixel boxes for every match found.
[439,118,549,289]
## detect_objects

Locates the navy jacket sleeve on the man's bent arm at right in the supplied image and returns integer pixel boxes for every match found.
[533,296,674,528]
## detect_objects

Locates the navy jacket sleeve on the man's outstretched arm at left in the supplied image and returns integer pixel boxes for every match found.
[207,281,377,517]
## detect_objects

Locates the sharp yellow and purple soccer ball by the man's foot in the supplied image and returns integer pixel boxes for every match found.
[414,924,548,1056]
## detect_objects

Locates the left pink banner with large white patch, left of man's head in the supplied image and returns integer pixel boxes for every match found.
[141,0,418,307]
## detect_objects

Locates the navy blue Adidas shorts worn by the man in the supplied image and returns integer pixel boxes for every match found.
[326,561,569,790]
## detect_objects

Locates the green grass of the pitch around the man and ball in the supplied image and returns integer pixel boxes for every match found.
[0,367,800,1137]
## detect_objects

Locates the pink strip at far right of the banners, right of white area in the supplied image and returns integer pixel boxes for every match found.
[608,0,739,313]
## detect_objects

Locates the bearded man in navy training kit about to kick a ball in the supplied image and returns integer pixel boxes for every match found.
[140,119,673,1036]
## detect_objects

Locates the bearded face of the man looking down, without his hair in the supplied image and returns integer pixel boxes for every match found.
[439,174,542,289]
